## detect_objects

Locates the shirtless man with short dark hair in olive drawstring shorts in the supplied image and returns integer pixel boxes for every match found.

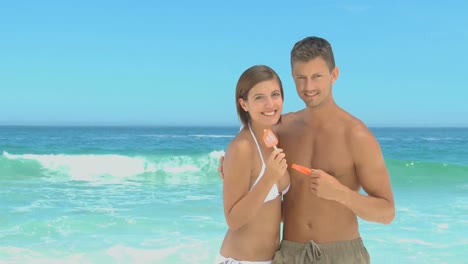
[220,37,395,264]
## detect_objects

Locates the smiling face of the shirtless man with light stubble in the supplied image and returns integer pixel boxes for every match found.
[292,57,338,107]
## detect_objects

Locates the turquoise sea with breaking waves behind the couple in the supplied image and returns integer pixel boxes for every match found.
[0,127,468,263]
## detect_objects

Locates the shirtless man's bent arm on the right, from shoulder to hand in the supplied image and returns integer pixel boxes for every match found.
[310,128,395,224]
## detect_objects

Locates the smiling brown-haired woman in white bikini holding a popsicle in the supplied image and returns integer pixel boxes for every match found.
[215,65,289,263]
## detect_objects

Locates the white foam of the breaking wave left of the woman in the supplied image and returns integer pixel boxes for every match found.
[3,150,224,183]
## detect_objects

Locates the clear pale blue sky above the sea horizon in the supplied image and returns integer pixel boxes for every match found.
[0,0,468,127]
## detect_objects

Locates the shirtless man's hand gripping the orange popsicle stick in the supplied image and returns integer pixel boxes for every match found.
[309,169,346,201]
